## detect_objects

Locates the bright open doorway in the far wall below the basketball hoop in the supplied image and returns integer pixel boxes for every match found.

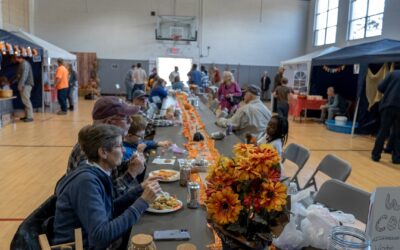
[157,57,192,86]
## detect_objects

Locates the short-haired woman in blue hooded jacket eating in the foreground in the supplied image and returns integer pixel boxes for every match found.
[54,124,161,249]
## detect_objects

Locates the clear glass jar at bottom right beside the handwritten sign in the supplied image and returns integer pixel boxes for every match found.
[328,226,371,250]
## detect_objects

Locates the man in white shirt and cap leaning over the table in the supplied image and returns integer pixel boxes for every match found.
[216,85,272,141]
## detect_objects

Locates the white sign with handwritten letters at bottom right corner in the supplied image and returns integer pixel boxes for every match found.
[367,187,400,250]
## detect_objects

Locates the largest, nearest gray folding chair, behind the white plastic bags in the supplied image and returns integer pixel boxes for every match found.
[314,179,371,224]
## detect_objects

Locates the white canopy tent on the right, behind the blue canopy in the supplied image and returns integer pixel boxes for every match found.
[281,46,339,94]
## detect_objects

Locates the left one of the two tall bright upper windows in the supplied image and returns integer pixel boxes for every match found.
[314,0,339,46]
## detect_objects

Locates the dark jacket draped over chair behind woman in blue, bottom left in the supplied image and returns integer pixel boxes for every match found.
[10,195,57,250]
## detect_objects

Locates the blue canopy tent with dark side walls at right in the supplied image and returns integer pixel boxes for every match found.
[310,39,400,134]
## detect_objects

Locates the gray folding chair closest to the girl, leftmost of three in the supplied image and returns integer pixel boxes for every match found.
[282,143,310,190]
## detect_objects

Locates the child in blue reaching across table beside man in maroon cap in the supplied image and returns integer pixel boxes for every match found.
[123,115,171,183]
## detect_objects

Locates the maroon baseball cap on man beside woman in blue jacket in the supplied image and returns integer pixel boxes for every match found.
[92,96,139,120]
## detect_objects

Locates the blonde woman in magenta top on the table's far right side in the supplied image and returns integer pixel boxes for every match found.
[217,71,242,113]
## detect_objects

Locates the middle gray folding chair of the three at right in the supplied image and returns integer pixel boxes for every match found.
[303,154,351,191]
